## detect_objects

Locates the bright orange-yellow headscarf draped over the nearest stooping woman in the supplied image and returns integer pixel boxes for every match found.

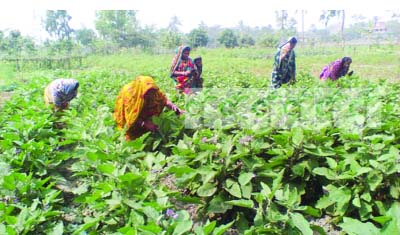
[114,76,167,129]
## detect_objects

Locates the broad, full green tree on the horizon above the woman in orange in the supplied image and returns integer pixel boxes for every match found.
[95,10,139,47]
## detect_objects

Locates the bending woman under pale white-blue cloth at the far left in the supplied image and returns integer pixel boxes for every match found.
[44,78,79,110]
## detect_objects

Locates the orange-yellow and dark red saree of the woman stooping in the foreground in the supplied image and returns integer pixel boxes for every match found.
[114,76,167,140]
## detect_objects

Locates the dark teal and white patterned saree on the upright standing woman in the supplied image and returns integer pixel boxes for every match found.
[271,41,296,88]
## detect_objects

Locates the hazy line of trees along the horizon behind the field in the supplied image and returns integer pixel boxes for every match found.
[0,10,400,60]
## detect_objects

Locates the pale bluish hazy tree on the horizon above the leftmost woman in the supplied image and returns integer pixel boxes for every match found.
[42,10,74,40]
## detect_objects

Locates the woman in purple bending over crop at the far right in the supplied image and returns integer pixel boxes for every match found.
[319,57,353,81]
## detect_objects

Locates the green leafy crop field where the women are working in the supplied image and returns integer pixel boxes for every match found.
[0,45,400,235]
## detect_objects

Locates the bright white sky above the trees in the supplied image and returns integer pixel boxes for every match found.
[0,0,400,40]
